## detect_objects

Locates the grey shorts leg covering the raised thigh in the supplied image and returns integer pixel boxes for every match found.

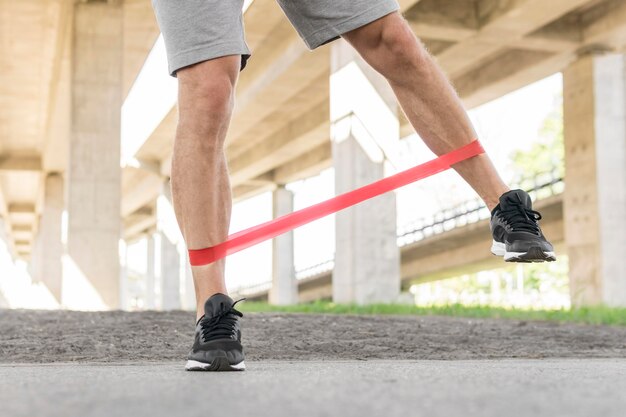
[277,0,399,49]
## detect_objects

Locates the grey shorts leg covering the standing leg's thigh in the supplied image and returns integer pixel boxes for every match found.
[152,0,250,76]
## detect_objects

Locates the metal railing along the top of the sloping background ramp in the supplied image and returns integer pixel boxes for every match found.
[234,171,565,295]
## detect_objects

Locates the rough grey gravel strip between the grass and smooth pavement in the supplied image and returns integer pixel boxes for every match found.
[0,310,626,363]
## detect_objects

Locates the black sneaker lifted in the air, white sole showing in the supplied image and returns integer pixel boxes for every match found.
[491,190,556,262]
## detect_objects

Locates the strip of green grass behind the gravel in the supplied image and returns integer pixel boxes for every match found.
[238,301,626,326]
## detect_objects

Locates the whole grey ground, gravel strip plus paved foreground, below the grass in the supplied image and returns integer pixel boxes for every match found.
[0,310,626,417]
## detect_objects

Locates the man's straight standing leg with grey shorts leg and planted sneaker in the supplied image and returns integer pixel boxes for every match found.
[152,0,250,371]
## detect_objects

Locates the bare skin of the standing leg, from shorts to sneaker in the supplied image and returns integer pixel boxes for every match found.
[172,56,240,318]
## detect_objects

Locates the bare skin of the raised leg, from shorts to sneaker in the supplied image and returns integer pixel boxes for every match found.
[343,13,509,210]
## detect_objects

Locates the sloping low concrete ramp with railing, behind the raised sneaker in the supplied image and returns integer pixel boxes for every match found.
[235,179,565,302]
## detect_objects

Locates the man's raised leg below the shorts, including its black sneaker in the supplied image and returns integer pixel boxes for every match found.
[344,13,556,262]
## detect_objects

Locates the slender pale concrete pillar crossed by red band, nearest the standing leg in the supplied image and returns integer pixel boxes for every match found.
[269,185,298,305]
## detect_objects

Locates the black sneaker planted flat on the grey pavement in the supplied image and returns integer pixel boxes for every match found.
[185,294,246,371]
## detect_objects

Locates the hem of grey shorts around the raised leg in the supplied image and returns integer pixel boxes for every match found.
[302,0,400,50]
